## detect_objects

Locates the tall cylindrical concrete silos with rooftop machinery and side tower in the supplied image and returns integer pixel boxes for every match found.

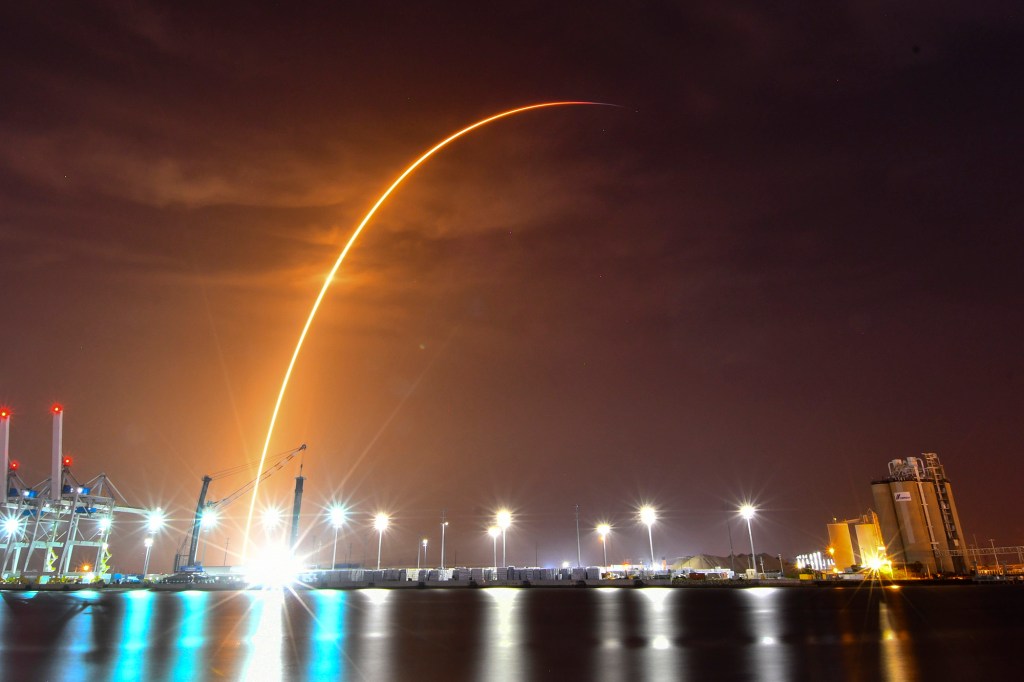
[872,453,971,576]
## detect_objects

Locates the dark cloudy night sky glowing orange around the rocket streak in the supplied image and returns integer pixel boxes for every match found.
[0,1,1024,570]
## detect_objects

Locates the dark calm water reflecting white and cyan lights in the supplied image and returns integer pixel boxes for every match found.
[0,586,1024,682]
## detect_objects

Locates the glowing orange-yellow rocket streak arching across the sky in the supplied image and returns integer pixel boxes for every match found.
[242,101,615,562]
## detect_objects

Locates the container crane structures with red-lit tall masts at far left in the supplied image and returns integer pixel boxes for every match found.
[0,404,153,583]
